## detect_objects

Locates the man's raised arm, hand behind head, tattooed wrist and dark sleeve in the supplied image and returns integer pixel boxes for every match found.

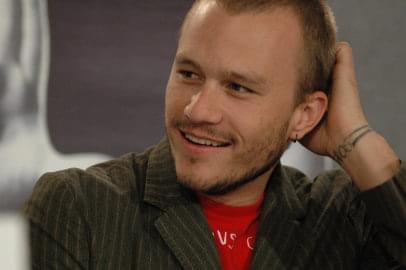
[301,43,406,265]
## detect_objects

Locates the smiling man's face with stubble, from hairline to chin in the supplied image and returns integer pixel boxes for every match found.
[165,1,302,194]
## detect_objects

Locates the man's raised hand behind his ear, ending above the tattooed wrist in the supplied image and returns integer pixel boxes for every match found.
[300,42,368,157]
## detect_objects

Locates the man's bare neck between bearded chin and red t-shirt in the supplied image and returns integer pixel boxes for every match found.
[201,167,274,206]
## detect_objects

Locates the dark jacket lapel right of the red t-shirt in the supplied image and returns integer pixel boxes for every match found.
[251,164,305,270]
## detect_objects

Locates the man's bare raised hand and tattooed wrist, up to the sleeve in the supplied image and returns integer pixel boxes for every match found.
[301,42,400,191]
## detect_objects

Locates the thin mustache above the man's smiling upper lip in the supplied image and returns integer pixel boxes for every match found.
[172,119,236,143]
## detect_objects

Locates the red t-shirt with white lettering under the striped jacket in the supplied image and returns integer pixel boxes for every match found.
[199,196,263,270]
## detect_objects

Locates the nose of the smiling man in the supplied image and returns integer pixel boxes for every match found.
[184,88,222,125]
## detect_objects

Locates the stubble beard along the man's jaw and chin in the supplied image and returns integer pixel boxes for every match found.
[167,118,289,195]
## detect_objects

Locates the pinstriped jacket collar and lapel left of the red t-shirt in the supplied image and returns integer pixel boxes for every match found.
[144,139,220,269]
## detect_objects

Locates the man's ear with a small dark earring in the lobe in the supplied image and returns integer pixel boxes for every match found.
[289,91,328,141]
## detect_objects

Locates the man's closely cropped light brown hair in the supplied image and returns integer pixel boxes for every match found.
[188,0,337,104]
